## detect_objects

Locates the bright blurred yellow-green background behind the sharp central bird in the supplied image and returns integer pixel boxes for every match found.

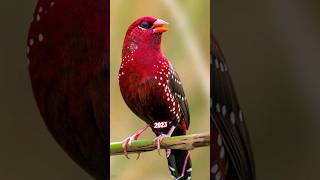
[110,0,210,180]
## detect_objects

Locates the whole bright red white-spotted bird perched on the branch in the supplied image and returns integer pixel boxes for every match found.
[118,17,192,180]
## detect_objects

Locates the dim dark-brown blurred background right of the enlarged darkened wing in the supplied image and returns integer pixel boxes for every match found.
[211,0,320,180]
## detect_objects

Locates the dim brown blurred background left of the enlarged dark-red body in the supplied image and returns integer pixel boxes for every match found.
[0,0,92,180]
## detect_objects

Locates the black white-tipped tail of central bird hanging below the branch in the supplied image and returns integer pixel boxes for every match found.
[167,149,192,180]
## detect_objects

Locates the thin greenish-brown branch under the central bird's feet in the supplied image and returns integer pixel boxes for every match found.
[110,133,210,156]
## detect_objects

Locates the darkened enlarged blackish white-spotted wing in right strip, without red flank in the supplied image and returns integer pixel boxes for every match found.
[210,36,255,180]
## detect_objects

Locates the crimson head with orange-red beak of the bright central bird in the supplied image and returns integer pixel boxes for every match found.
[123,16,168,51]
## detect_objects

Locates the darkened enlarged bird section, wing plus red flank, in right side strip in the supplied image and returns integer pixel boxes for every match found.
[210,35,255,180]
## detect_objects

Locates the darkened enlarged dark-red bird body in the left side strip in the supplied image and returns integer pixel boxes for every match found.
[27,0,109,180]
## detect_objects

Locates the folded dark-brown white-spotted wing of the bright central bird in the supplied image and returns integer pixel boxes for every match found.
[169,64,190,129]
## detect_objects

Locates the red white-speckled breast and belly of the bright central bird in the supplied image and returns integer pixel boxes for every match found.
[119,57,180,129]
